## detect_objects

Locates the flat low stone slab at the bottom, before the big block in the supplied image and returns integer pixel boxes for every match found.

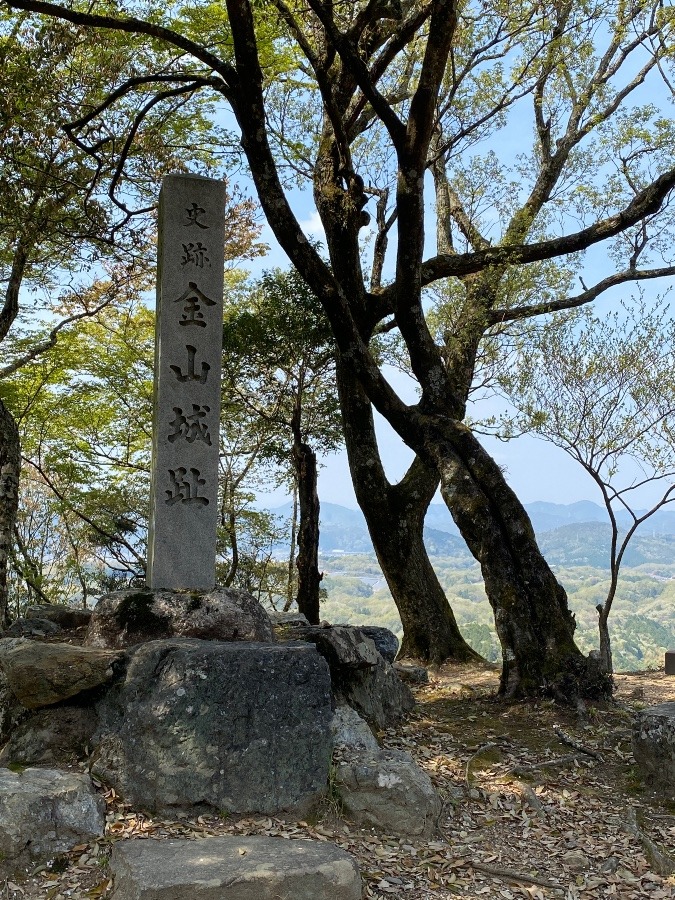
[110,836,361,900]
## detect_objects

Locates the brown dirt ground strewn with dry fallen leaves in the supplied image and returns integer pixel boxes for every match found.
[5,666,675,900]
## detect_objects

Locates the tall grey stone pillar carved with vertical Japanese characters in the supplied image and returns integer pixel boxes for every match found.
[147,175,225,591]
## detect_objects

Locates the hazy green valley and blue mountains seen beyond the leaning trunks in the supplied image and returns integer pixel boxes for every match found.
[321,502,675,671]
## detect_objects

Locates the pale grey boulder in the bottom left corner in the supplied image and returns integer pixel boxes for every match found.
[0,769,105,874]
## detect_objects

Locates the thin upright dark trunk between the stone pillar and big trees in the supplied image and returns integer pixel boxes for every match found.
[293,439,323,625]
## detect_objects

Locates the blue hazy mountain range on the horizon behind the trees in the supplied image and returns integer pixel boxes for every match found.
[272,500,675,568]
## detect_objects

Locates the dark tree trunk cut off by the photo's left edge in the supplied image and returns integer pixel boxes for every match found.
[0,400,21,629]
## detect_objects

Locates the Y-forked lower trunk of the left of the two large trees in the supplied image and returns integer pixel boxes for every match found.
[338,363,480,663]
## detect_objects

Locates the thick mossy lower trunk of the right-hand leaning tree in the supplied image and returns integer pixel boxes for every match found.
[427,420,612,702]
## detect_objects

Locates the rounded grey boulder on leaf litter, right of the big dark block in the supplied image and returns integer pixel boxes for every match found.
[336,750,442,837]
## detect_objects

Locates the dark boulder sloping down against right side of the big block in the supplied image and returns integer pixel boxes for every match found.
[278,625,415,728]
